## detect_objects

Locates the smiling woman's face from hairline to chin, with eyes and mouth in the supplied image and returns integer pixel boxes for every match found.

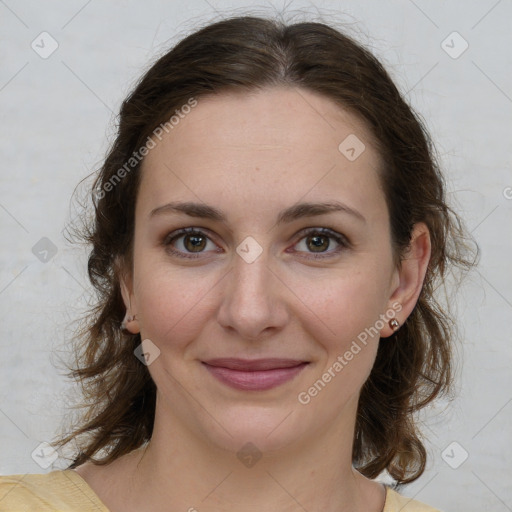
[122,88,408,456]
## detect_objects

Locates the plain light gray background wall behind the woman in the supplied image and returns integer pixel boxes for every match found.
[0,0,512,512]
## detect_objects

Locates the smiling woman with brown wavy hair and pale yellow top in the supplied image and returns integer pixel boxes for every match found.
[0,17,471,512]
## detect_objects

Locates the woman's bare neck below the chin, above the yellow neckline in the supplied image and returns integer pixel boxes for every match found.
[118,392,385,512]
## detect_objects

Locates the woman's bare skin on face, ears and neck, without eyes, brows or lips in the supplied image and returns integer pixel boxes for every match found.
[77,87,430,512]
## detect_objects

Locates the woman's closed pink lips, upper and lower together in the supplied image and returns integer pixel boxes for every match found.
[202,358,309,391]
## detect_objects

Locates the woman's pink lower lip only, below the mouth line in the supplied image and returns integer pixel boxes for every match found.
[203,363,308,391]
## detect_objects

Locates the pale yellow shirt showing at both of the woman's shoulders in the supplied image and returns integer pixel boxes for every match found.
[0,469,440,512]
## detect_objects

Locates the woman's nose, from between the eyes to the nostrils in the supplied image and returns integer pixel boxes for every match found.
[217,246,289,341]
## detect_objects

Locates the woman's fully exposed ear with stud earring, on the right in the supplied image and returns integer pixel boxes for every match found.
[381,222,431,338]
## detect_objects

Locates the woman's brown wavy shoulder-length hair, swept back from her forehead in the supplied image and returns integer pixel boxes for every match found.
[52,16,476,485]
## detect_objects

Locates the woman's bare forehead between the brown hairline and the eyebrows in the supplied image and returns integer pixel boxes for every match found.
[138,87,383,226]
